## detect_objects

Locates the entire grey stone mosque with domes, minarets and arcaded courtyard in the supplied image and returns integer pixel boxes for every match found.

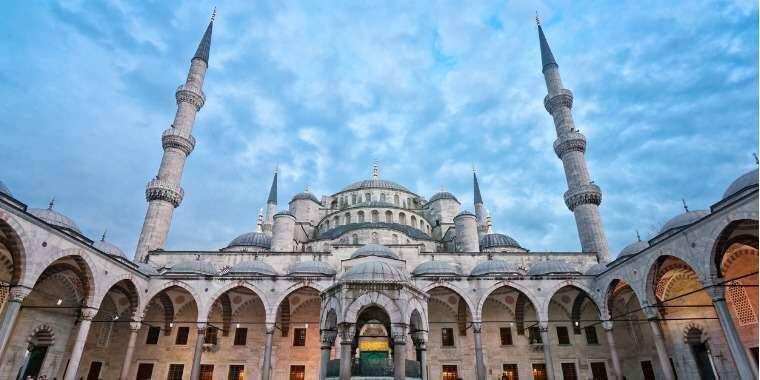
[0,12,758,380]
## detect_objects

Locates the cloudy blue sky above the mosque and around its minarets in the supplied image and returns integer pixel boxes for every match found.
[0,0,758,256]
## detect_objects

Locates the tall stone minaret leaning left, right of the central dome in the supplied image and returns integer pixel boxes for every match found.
[536,16,609,262]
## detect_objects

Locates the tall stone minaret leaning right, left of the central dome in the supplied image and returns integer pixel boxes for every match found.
[135,10,216,261]
